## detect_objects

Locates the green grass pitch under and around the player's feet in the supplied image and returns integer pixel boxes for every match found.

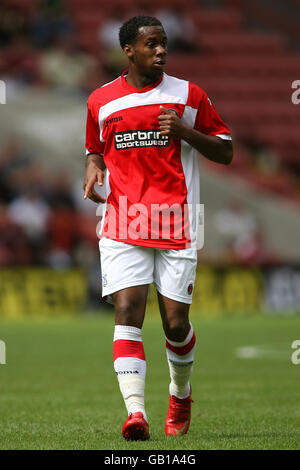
[0,312,300,450]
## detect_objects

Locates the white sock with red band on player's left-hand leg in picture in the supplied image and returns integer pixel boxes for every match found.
[113,325,147,420]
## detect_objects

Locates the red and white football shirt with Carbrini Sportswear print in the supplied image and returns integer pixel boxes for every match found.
[86,72,231,249]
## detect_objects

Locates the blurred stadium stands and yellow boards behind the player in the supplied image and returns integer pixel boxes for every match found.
[0,0,300,318]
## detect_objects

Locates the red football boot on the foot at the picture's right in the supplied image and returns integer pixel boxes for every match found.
[165,393,193,436]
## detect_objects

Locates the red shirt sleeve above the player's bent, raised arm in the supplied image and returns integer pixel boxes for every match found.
[194,92,231,140]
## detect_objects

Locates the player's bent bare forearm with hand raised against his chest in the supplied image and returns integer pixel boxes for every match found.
[158,106,233,165]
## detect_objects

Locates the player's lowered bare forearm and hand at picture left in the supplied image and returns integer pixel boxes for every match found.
[83,153,106,203]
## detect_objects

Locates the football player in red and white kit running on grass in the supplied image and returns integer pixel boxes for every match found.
[84,16,233,440]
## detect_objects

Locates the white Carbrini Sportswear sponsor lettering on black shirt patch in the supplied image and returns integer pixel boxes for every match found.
[115,129,170,150]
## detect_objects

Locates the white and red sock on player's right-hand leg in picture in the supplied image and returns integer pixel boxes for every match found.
[166,323,196,399]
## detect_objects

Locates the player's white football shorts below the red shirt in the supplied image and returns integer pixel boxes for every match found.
[99,237,197,304]
